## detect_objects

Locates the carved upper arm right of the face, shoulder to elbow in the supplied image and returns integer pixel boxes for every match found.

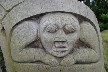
[80,21,99,52]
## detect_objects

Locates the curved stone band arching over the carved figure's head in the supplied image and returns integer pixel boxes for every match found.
[2,0,99,38]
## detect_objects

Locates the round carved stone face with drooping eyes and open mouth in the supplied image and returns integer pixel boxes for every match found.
[40,13,80,57]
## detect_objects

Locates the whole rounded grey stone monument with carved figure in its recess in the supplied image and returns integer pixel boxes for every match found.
[0,0,105,72]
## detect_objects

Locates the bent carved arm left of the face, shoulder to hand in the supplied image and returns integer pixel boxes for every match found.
[11,19,58,66]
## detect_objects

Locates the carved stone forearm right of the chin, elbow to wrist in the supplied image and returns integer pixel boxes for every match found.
[73,48,99,64]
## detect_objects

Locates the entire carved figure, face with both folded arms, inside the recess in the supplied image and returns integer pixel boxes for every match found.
[10,13,99,66]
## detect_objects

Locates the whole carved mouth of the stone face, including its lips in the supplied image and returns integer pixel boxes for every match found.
[54,41,68,52]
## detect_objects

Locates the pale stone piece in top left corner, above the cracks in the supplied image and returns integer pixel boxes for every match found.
[0,0,24,10]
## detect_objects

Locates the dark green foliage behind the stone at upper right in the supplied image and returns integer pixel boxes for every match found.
[84,0,108,31]
